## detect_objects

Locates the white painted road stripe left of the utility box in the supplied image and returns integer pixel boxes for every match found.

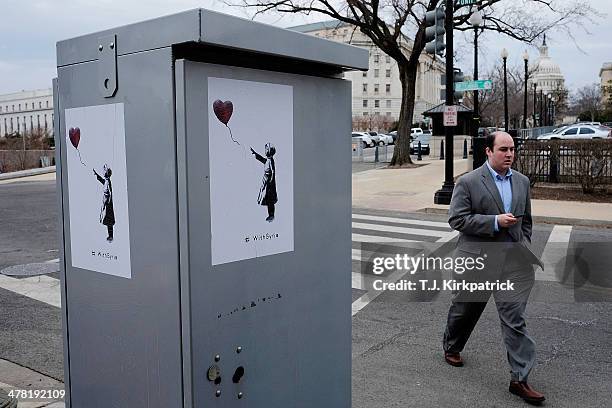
[0,275,62,307]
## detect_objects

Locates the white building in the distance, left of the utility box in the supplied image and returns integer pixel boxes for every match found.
[0,88,53,137]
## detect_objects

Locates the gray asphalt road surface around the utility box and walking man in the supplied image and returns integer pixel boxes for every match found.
[0,177,612,408]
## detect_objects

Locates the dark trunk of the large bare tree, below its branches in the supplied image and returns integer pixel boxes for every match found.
[391,61,418,166]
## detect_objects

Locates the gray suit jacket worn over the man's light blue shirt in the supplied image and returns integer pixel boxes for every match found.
[448,163,544,269]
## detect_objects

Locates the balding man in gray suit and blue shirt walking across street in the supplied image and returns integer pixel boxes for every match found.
[443,132,545,403]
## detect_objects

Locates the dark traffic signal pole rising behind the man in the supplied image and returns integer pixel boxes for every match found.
[434,0,455,204]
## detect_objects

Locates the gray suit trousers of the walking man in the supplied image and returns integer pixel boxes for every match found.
[443,266,535,381]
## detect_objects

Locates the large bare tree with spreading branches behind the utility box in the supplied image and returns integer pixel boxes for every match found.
[225,0,597,166]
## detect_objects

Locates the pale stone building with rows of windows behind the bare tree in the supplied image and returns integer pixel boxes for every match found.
[289,20,445,130]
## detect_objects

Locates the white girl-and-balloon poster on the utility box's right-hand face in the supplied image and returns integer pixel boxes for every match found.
[208,78,293,265]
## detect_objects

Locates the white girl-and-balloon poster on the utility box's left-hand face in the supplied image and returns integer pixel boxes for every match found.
[65,103,132,278]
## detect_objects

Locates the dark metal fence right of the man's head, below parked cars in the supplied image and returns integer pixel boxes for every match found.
[513,139,612,186]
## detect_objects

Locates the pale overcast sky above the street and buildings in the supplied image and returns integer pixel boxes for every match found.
[0,0,612,94]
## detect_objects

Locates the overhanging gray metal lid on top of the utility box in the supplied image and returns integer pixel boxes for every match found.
[57,9,368,70]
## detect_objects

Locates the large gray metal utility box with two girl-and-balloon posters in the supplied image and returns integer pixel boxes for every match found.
[54,9,368,408]
